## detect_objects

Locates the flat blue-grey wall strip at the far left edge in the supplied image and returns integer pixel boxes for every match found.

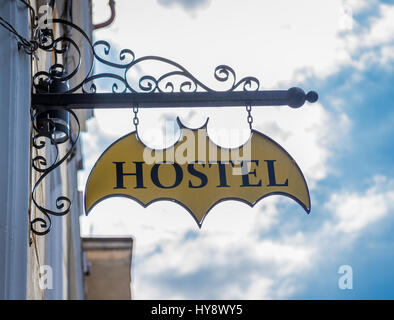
[0,1,30,299]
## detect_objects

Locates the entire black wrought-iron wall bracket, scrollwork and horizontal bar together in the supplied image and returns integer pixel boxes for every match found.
[31,19,318,235]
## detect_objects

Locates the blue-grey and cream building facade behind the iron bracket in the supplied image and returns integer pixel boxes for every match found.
[0,0,97,299]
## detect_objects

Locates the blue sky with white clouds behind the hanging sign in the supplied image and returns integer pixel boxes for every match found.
[79,0,394,299]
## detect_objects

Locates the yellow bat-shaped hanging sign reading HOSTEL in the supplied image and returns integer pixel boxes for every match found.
[85,119,311,227]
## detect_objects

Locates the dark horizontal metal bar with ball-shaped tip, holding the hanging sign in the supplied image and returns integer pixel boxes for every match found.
[32,88,317,109]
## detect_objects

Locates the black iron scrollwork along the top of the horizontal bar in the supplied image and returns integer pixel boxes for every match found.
[33,19,260,93]
